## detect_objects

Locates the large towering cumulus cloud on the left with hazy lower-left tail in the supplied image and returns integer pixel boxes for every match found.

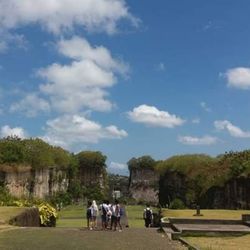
[11,36,129,116]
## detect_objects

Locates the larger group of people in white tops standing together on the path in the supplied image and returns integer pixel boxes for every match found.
[87,200,123,231]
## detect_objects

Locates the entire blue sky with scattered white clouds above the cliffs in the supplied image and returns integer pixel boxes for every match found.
[0,0,250,174]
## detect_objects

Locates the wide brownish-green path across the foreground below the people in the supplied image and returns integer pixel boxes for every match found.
[0,228,186,250]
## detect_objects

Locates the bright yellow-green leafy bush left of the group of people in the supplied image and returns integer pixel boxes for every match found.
[38,203,57,227]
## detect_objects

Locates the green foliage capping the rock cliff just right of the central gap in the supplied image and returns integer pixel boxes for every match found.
[127,155,156,171]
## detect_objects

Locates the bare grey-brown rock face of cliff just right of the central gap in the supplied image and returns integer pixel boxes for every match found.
[129,168,159,205]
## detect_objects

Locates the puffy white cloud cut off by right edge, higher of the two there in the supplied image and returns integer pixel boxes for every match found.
[224,67,250,89]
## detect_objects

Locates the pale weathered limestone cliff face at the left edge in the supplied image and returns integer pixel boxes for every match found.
[0,166,68,198]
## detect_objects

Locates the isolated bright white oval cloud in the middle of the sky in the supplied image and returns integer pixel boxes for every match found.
[128,104,185,128]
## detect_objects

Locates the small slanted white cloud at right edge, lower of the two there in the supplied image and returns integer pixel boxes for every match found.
[214,120,250,138]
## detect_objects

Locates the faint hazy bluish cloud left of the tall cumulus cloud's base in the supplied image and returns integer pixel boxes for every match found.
[10,93,50,117]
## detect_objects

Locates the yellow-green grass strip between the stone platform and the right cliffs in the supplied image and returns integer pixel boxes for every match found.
[163,209,250,220]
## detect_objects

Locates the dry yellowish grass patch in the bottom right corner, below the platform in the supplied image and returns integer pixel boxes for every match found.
[185,235,250,250]
